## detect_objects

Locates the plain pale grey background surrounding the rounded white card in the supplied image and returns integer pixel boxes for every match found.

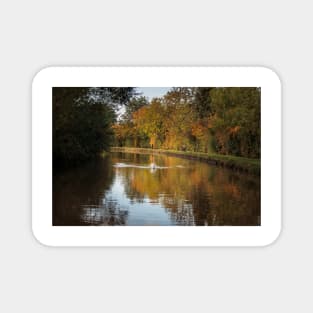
[0,0,313,312]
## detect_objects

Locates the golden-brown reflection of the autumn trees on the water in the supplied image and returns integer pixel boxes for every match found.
[118,157,260,225]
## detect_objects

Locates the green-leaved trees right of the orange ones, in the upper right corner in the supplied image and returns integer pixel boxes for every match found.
[211,87,261,158]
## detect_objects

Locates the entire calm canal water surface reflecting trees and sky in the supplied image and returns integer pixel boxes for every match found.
[53,152,261,226]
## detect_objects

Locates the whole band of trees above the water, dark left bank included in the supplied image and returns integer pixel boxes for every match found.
[52,87,261,165]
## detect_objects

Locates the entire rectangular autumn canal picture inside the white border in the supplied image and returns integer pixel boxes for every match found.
[52,86,262,227]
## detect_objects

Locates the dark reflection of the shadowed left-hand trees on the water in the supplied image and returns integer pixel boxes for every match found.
[53,158,127,225]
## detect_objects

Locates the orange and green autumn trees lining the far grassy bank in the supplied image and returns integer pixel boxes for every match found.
[113,87,261,158]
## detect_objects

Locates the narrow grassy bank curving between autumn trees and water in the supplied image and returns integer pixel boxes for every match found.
[111,147,261,175]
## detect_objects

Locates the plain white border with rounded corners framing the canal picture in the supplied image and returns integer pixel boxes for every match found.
[32,67,281,246]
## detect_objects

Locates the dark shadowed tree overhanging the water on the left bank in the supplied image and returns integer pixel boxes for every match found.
[52,87,133,165]
